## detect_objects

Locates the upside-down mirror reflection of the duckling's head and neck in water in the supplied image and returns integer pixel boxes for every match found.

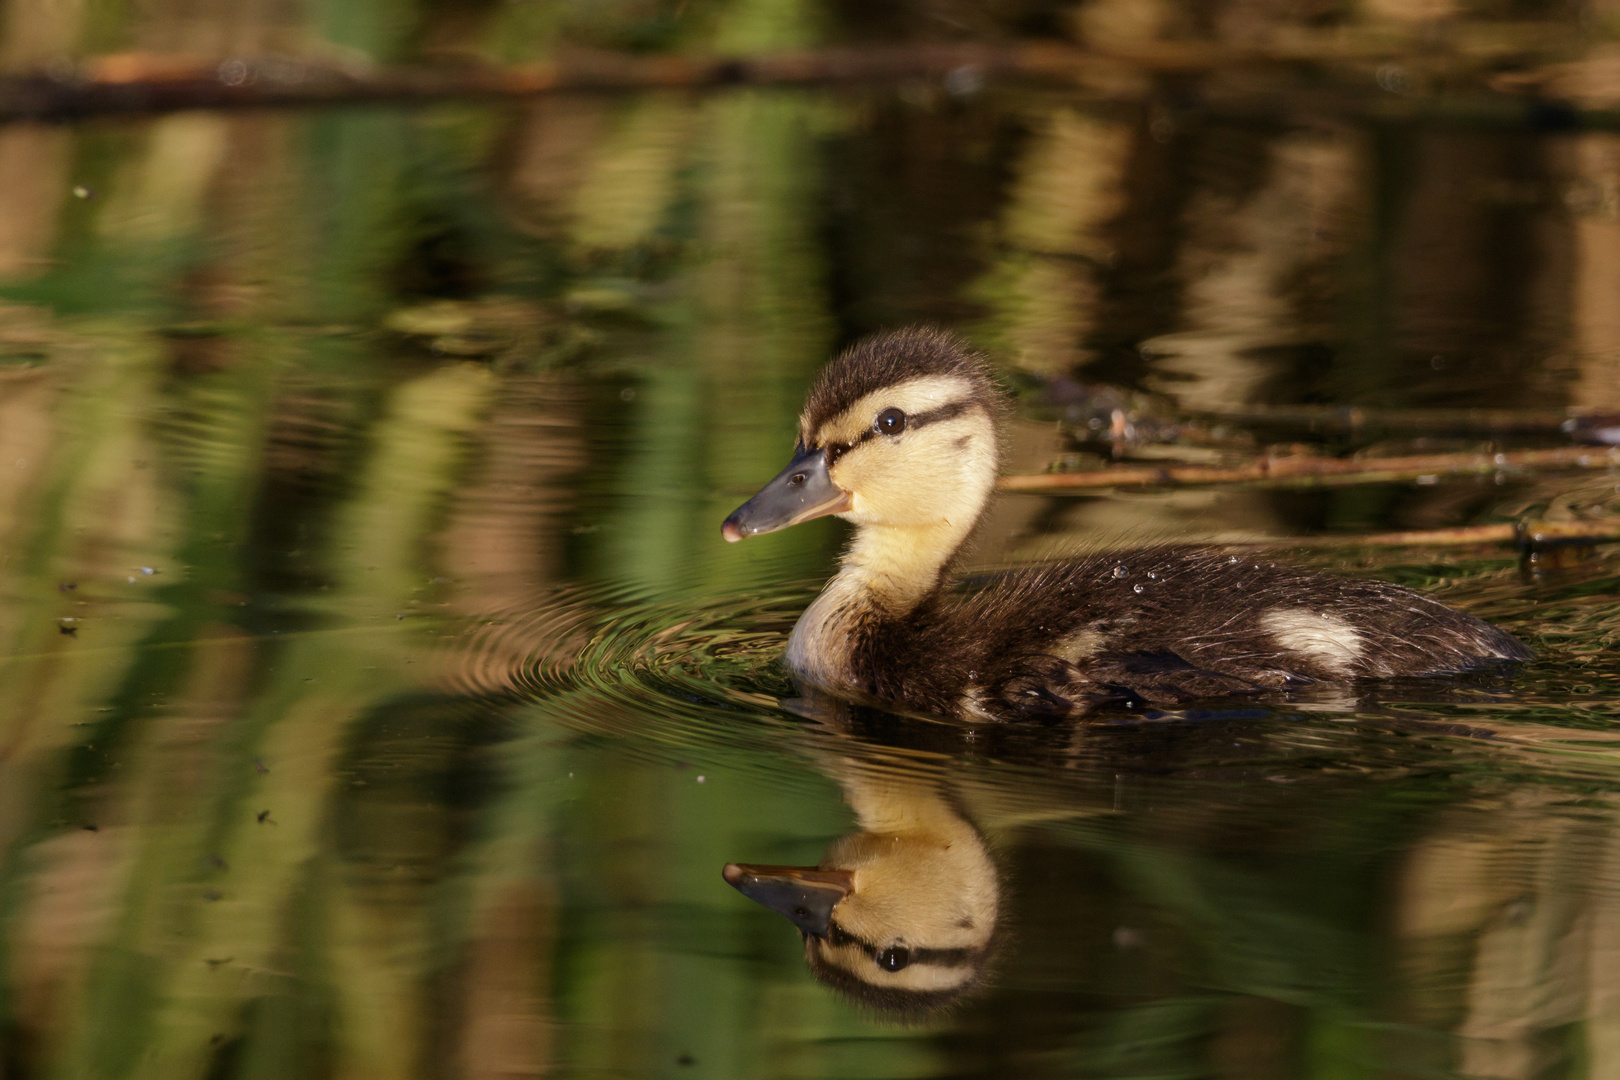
[724,771,1000,1015]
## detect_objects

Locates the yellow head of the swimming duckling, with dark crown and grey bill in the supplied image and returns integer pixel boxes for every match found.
[721,329,1000,541]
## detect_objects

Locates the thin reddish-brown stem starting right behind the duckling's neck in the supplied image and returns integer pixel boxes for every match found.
[1000,447,1620,495]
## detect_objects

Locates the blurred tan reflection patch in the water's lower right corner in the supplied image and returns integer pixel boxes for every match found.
[1395,790,1620,1080]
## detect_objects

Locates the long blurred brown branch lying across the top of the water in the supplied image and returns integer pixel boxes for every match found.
[0,38,1620,130]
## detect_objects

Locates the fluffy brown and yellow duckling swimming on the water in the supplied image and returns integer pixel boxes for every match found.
[721,329,1531,719]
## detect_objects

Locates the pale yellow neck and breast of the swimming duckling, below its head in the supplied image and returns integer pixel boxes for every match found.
[787,520,974,688]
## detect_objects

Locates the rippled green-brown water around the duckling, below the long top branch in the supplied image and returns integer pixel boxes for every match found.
[0,87,1620,1080]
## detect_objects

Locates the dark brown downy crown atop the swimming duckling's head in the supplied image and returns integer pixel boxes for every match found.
[804,327,998,434]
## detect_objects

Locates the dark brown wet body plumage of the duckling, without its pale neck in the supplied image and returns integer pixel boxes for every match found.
[852,547,1531,717]
